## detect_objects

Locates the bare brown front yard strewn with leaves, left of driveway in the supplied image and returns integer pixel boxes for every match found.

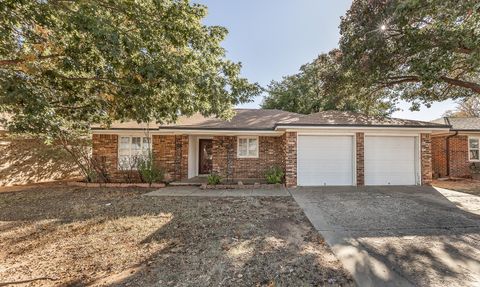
[0,185,354,286]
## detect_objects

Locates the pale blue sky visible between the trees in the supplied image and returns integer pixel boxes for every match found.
[193,0,455,120]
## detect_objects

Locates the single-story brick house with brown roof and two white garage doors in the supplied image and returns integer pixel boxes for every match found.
[92,109,449,186]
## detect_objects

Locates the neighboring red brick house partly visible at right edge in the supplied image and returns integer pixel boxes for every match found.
[432,117,480,177]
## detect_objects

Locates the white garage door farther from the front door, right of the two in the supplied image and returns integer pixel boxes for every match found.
[364,136,416,185]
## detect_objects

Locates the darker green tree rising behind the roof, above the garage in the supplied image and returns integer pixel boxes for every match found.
[262,50,393,115]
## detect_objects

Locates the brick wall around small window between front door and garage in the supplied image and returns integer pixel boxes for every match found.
[212,136,285,180]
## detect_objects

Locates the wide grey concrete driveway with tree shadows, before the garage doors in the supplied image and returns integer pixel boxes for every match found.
[290,186,480,286]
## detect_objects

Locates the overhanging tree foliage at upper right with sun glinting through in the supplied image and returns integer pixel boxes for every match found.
[340,0,480,109]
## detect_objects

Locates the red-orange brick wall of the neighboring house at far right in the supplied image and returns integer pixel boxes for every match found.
[432,135,471,177]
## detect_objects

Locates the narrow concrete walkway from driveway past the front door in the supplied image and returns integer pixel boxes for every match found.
[145,186,290,197]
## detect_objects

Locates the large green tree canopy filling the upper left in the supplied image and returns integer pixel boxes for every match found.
[0,0,259,141]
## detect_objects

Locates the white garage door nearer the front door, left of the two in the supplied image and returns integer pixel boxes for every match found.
[297,136,353,186]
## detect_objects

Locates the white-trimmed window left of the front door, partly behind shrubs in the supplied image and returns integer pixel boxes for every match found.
[118,136,151,170]
